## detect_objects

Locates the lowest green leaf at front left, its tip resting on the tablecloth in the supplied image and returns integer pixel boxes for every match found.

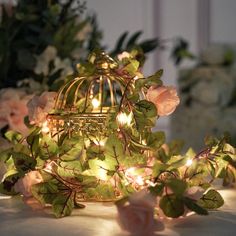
[52,192,74,218]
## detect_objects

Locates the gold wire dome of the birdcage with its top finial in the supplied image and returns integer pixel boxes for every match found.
[52,52,131,114]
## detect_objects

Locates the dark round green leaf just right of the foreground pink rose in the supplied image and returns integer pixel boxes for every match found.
[160,194,184,218]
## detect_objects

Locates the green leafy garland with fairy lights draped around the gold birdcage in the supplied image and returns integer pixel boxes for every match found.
[0,51,236,218]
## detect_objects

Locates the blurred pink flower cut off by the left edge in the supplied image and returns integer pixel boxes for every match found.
[0,89,30,135]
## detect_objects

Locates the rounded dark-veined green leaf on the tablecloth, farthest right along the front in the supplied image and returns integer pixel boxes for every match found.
[197,189,224,209]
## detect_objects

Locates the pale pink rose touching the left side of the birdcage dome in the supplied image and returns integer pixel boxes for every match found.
[27,92,57,126]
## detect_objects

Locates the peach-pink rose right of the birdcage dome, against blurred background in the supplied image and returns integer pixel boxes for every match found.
[146,86,180,116]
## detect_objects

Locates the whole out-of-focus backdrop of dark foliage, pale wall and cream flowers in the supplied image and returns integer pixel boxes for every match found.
[0,0,236,149]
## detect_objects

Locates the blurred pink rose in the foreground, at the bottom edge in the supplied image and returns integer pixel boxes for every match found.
[117,190,155,235]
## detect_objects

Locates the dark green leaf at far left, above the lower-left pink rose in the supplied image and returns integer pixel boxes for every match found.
[12,152,37,173]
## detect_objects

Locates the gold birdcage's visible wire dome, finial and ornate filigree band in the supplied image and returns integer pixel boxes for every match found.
[47,52,132,136]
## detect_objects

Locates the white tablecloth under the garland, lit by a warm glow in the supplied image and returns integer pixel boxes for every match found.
[0,189,236,236]
